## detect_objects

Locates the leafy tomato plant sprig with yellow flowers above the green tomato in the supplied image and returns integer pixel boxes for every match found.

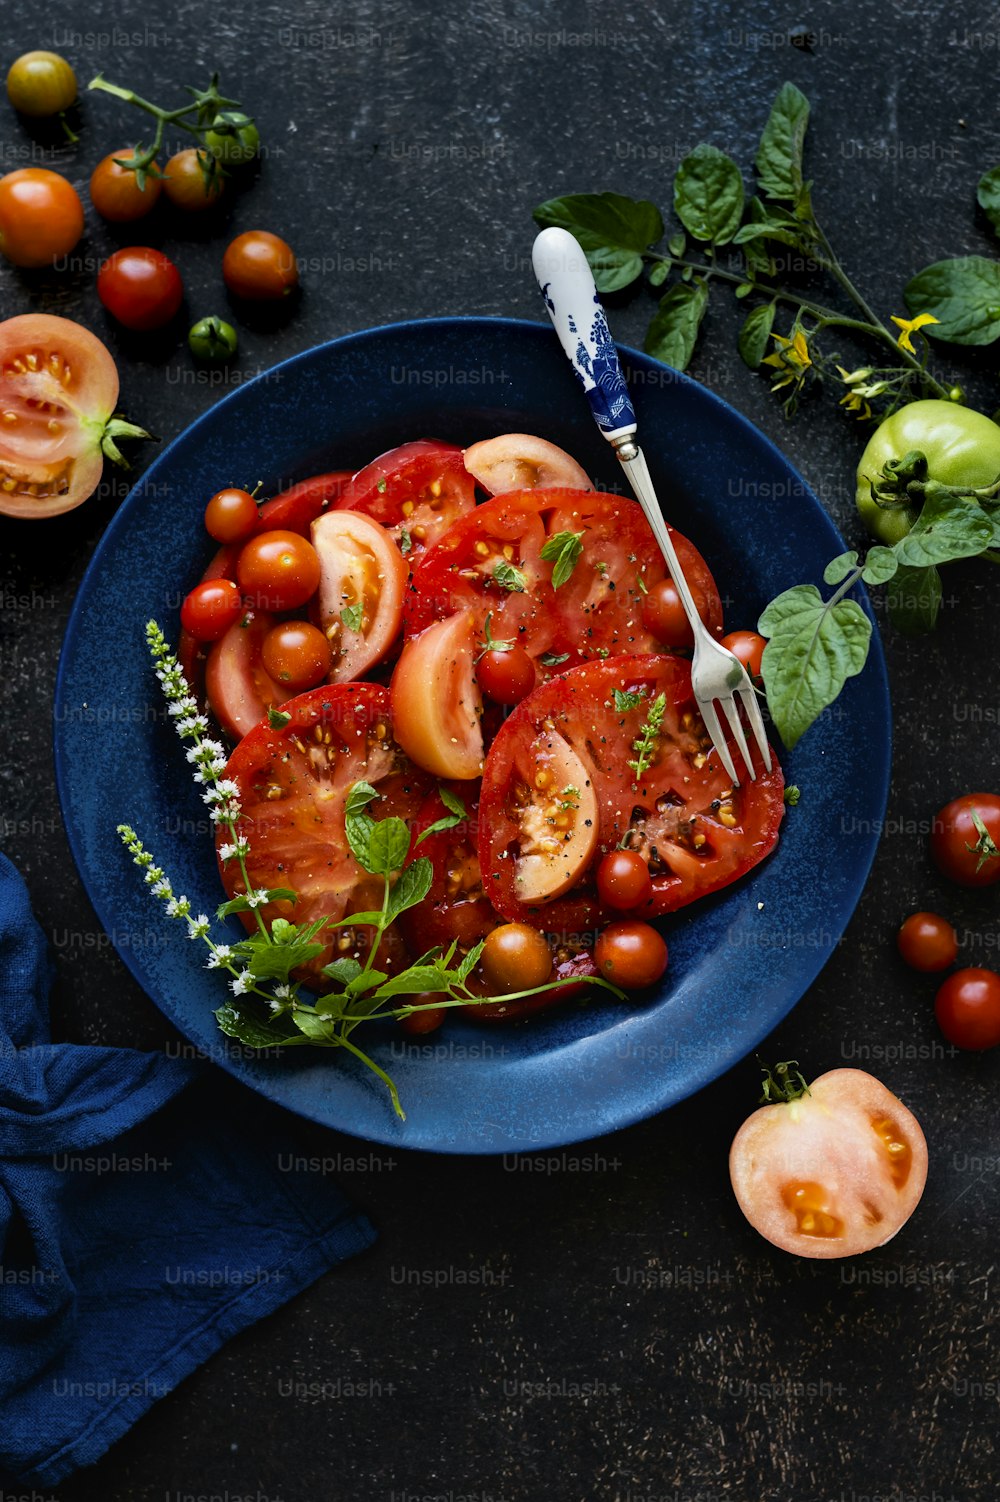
[535,83,962,418]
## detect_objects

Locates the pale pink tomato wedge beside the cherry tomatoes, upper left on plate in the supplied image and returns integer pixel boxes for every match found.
[312,511,408,683]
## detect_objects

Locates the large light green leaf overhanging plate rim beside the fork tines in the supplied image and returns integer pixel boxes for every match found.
[758,584,871,751]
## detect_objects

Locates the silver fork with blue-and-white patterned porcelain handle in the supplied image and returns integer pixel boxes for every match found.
[532,227,770,786]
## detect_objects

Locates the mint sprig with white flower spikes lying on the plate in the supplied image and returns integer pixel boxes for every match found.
[117,620,625,1119]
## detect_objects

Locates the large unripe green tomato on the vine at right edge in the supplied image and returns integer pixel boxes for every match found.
[854,401,1000,547]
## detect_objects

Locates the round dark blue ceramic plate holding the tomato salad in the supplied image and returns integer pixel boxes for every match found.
[56,318,890,1152]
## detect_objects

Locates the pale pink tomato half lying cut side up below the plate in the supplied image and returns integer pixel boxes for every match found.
[730,1069,926,1257]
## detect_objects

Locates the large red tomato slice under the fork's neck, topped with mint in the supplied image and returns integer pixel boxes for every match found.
[404,488,722,682]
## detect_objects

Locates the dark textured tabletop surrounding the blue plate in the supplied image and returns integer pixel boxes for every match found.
[0,0,1000,1502]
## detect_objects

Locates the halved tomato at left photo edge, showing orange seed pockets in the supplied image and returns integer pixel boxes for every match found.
[0,312,120,520]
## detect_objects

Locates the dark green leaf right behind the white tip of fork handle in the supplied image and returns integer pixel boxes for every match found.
[533,192,664,291]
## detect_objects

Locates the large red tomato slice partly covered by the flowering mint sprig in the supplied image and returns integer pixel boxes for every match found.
[216,683,429,973]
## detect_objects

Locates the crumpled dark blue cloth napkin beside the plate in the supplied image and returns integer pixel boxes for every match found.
[0,855,374,1485]
